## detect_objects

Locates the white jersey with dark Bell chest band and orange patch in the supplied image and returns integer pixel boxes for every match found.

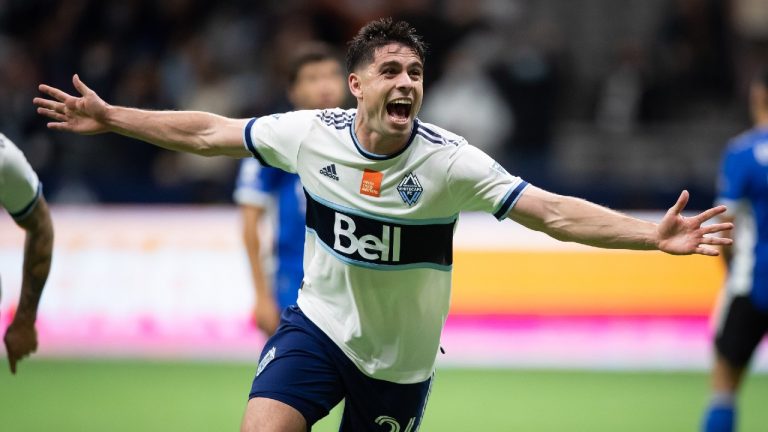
[244,109,527,383]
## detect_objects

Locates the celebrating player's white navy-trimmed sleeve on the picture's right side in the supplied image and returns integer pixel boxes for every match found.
[448,144,528,220]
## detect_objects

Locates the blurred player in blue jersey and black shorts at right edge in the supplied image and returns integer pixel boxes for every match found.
[702,71,768,432]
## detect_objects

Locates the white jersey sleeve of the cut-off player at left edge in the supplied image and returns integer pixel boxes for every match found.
[0,134,41,220]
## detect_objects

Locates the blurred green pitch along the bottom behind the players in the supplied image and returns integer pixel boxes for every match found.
[0,360,768,432]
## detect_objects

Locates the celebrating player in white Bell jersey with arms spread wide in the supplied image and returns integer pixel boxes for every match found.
[34,19,732,432]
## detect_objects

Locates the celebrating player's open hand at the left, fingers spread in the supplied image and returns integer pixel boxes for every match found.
[33,75,110,135]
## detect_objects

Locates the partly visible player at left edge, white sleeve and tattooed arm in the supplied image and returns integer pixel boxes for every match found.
[0,134,53,374]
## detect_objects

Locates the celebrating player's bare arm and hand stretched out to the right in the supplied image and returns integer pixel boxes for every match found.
[508,186,733,256]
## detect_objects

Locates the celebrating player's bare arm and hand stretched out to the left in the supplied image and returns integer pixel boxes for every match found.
[33,75,250,157]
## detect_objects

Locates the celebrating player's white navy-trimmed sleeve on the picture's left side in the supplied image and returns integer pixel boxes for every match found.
[243,110,318,173]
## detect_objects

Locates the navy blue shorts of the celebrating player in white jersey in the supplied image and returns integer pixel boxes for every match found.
[249,305,432,432]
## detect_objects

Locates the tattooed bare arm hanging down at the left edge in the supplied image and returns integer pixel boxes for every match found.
[4,195,53,374]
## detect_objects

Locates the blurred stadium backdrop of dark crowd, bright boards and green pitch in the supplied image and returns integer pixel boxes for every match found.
[0,0,768,431]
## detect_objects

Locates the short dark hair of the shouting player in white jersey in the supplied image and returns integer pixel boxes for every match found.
[347,18,427,73]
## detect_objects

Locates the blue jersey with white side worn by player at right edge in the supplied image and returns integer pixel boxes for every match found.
[718,128,768,311]
